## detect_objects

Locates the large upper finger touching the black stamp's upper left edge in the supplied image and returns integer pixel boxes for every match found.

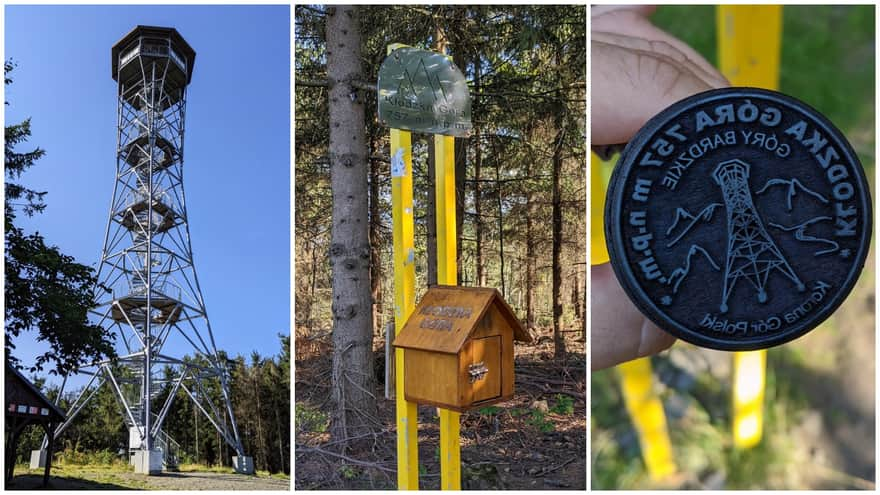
[590,41,713,145]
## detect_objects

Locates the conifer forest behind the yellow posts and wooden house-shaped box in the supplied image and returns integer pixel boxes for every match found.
[294,5,586,489]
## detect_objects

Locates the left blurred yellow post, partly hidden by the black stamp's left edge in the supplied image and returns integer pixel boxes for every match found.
[590,153,676,480]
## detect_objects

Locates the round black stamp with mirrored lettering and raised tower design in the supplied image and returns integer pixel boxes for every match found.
[605,88,872,350]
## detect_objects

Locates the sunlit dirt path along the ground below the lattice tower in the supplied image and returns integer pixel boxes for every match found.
[5,469,290,491]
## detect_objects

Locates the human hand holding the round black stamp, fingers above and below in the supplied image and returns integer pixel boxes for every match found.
[590,6,729,370]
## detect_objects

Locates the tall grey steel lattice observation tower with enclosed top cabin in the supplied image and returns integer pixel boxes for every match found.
[32,26,254,473]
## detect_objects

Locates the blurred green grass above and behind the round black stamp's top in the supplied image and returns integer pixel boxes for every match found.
[653,5,875,170]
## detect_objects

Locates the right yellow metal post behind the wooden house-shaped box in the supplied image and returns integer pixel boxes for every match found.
[434,134,461,490]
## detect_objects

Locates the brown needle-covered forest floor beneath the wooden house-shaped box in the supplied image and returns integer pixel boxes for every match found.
[294,332,587,490]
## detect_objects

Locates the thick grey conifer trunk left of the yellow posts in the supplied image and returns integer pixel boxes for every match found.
[326,5,377,449]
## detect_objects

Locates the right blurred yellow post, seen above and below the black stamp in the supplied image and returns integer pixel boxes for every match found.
[716,5,782,448]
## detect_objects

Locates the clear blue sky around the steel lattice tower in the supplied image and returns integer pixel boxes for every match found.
[5,5,290,384]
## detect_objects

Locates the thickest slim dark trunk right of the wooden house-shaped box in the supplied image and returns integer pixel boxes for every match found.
[552,108,565,358]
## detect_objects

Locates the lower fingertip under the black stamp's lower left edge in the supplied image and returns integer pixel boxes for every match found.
[590,263,675,370]
